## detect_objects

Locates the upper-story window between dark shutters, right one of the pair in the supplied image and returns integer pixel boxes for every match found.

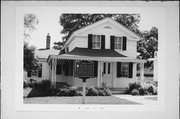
[114,37,123,50]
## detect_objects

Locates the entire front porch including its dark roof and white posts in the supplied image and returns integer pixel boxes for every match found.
[48,48,146,88]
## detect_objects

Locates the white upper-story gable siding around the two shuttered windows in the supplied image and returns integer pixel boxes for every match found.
[68,23,137,58]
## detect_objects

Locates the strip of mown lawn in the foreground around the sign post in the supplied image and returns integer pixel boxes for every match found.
[24,96,139,104]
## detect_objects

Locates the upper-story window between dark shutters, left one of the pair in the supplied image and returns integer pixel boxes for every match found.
[92,35,101,49]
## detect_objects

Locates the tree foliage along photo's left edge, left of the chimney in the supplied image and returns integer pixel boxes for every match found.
[24,14,38,72]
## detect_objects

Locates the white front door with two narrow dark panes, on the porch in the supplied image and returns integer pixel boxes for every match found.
[102,62,112,88]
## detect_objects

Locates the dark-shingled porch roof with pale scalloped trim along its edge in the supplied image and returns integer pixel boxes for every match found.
[48,48,146,63]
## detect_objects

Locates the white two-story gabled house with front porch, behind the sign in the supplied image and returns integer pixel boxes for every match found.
[46,18,146,88]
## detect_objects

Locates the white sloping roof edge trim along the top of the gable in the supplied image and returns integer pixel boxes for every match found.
[62,17,140,49]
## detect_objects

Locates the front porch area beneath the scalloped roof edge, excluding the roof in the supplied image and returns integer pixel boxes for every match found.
[49,58,144,88]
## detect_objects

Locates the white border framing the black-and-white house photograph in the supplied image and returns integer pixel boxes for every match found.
[15,6,166,111]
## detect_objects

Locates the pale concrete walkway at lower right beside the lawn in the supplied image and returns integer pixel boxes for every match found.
[113,94,158,105]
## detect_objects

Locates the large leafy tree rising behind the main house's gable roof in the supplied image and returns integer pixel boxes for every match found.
[53,14,140,49]
